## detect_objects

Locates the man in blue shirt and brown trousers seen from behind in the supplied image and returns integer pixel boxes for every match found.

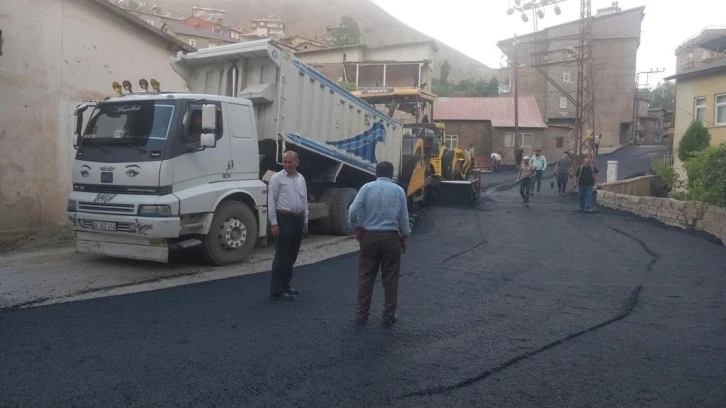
[348,162,411,325]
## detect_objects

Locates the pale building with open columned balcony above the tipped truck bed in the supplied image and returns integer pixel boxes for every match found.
[295,41,439,91]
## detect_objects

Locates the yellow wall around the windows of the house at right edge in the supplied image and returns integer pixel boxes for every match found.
[673,73,726,179]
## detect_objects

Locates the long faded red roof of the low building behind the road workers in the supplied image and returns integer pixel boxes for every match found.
[434,96,547,129]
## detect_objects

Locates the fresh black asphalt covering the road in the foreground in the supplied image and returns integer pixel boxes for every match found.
[0,144,726,407]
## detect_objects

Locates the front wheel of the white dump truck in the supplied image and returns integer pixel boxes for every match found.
[202,201,259,266]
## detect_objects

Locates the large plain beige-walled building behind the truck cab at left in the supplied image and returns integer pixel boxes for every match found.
[0,0,194,230]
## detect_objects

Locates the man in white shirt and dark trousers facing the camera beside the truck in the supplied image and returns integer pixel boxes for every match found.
[267,150,308,300]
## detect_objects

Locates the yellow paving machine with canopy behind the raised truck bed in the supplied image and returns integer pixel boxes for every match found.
[353,88,481,205]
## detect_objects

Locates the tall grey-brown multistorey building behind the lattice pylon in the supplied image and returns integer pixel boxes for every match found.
[498,5,645,146]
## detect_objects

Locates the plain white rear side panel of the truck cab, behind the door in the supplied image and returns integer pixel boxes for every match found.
[226,103,260,180]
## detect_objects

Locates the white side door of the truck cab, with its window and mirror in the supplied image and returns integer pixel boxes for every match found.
[173,102,232,210]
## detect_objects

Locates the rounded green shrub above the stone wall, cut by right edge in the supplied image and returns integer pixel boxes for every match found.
[684,143,726,207]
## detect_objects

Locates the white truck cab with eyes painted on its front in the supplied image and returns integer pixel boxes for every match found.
[68,90,267,265]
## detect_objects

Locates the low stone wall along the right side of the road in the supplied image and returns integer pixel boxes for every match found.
[597,189,726,245]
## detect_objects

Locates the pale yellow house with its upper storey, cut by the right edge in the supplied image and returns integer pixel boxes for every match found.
[666,28,726,177]
